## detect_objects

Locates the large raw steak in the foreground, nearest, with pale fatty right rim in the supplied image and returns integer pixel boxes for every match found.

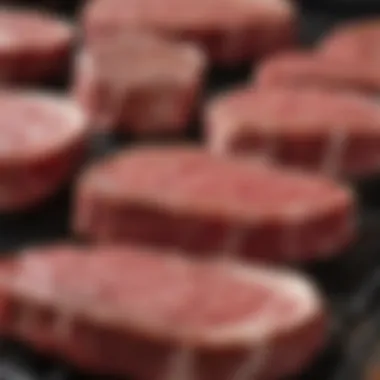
[0,245,326,380]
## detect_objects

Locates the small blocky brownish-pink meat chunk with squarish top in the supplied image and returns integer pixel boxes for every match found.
[73,32,206,136]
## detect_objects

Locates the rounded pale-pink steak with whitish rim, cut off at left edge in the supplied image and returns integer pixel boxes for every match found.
[0,90,87,212]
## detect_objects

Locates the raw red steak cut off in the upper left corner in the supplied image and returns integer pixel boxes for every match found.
[0,7,75,83]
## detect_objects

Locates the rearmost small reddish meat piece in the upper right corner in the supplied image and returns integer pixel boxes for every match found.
[318,18,380,65]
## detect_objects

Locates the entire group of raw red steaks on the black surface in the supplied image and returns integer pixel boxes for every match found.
[0,0,380,380]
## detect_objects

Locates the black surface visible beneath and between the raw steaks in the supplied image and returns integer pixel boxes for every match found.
[0,0,380,380]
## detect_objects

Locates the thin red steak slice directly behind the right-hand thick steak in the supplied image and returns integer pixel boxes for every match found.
[253,51,380,95]
